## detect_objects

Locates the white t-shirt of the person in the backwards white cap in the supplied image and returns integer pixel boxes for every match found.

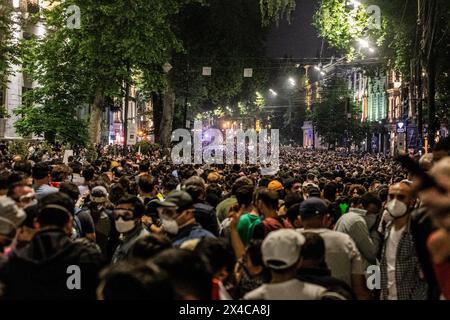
[244,279,326,300]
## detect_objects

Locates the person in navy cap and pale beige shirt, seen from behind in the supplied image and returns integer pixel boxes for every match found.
[300,197,370,299]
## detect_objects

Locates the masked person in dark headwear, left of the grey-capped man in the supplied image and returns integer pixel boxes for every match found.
[112,196,150,263]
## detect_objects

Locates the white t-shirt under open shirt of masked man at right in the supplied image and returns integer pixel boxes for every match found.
[386,226,406,300]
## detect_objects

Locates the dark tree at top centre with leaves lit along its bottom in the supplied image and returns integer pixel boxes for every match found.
[170,0,269,126]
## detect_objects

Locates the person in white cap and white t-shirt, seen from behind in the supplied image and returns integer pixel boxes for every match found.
[244,229,326,300]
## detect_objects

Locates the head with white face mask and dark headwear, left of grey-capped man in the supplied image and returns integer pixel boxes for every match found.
[114,195,145,233]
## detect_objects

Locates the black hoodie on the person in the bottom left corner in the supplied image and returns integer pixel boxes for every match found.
[0,228,103,300]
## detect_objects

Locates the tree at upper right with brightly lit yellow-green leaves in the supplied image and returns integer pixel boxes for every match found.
[315,0,450,145]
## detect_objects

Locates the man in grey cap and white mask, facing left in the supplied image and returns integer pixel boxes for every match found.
[155,190,215,247]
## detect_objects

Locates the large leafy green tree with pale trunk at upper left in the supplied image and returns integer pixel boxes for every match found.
[15,0,185,143]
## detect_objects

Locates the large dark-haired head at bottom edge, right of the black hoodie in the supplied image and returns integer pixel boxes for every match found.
[97,260,175,300]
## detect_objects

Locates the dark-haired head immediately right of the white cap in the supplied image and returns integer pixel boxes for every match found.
[300,232,326,268]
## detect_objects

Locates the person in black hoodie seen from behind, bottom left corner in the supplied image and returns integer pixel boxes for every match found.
[0,192,103,300]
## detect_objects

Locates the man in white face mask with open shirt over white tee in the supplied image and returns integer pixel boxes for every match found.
[381,181,427,300]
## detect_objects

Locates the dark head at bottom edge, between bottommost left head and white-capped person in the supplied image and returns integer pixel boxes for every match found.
[152,249,213,300]
